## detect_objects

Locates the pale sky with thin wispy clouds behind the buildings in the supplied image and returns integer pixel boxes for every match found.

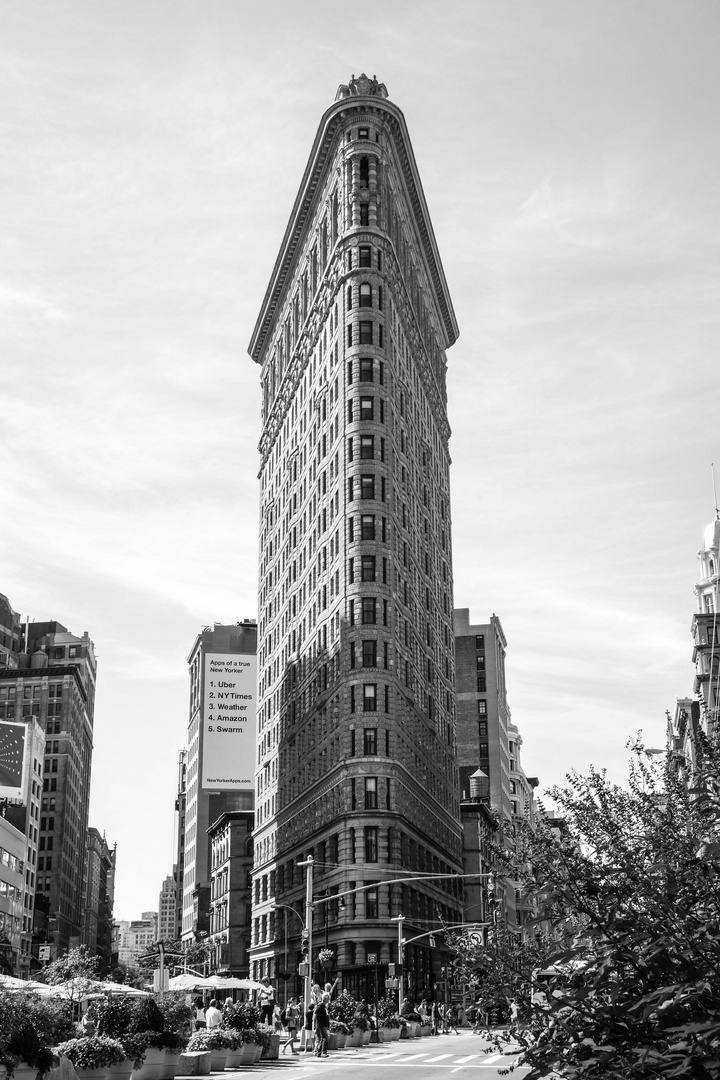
[0,0,720,918]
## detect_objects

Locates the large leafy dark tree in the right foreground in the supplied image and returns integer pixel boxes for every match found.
[496,740,720,1080]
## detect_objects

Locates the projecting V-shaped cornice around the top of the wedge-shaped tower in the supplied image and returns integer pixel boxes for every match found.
[248,95,459,363]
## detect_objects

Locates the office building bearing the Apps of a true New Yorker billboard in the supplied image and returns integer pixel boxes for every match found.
[177,619,257,941]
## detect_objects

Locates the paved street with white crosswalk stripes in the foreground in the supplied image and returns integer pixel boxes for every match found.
[225,1030,528,1080]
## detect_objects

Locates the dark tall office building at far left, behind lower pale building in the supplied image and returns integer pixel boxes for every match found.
[0,598,96,959]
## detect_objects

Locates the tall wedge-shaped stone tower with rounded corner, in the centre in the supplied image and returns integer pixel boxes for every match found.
[249,76,462,997]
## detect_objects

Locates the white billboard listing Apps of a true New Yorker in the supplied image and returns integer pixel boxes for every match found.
[200,652,258,792]
